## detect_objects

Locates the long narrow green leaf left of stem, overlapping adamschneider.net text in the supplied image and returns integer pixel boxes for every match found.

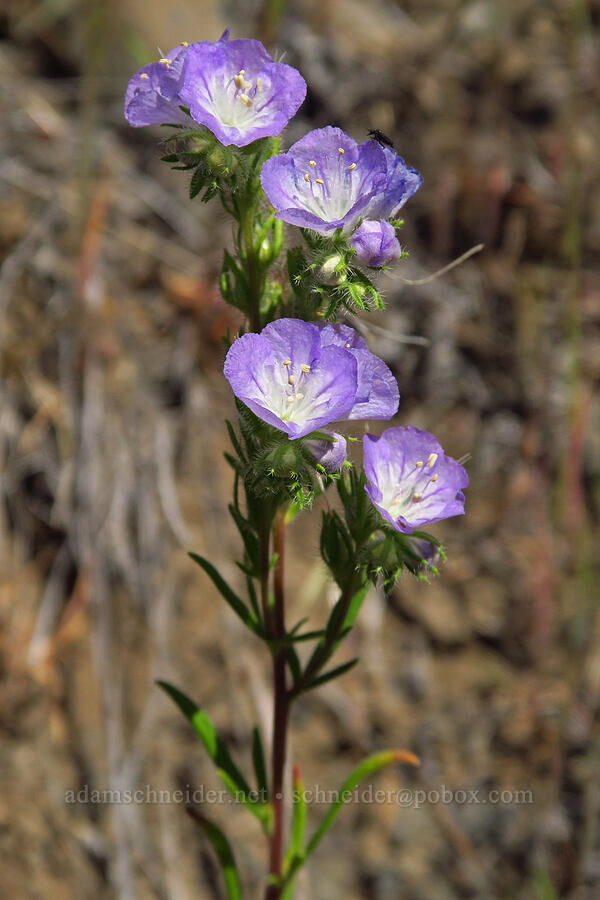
[156,681,270,824]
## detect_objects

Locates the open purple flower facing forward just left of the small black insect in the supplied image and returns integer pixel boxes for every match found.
[260,126,387,234]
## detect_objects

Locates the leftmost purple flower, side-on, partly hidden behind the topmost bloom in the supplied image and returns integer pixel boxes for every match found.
[125,42,197,128]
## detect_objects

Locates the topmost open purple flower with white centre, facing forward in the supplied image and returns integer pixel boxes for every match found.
[180,39,306,147]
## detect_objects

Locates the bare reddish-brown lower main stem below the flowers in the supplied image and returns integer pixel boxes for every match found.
[265,511,289,900]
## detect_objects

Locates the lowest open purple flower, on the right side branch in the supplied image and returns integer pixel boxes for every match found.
[364,425,469,534]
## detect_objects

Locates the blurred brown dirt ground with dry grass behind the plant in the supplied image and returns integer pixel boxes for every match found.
[0,0,600,900]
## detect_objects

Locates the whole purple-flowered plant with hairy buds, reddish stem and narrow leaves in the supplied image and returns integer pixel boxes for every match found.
[125,30,468,900]
